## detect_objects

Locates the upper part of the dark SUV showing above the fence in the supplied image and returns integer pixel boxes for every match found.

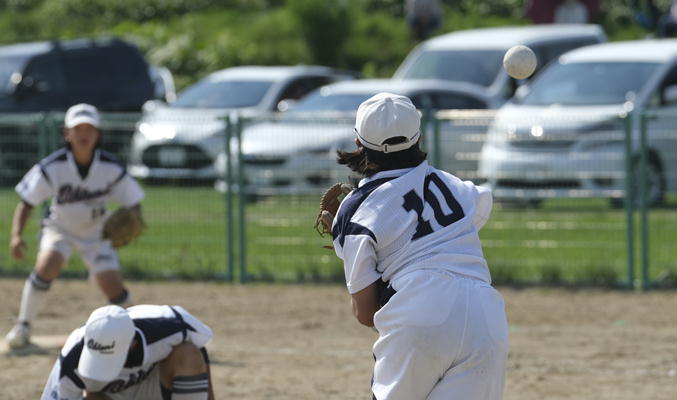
[0,39,155,113]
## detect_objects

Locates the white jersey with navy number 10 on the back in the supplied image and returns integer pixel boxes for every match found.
[332,161,493,293]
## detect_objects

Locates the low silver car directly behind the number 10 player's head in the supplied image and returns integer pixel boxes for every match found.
[217,79,492,195]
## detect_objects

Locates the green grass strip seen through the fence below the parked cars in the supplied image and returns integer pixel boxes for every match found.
[0,186,677,286]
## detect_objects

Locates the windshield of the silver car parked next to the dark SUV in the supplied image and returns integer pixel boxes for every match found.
[173,79,273,108]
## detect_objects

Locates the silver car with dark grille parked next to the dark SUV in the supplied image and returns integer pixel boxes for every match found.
[128,65,355,180]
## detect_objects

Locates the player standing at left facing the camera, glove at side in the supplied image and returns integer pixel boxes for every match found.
[6,104,144,348]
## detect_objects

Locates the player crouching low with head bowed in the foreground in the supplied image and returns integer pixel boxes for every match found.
[41,305,214,400]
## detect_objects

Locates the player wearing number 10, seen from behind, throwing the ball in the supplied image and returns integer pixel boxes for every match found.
[332,93,508,400]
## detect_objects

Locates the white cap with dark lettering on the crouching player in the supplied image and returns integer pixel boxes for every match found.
[78,305,136,382]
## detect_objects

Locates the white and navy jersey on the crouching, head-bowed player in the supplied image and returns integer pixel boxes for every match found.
[41,305,212,400]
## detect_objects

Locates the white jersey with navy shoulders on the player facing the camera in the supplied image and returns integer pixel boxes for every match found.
[15,148,144,238]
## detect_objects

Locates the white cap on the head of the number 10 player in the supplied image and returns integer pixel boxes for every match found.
[355,92,421,153]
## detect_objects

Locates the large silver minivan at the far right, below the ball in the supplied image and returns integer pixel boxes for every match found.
[479,39,677,204]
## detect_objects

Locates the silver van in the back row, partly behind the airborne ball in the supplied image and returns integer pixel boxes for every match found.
[393,24,607,107]
